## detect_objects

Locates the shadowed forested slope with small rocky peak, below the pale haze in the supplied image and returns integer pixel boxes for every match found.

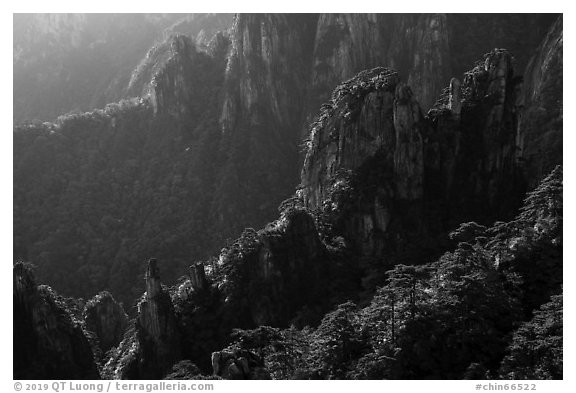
[14,36,225,304]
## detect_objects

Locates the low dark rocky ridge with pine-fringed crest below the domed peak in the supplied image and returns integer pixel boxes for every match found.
[158,205,358,379]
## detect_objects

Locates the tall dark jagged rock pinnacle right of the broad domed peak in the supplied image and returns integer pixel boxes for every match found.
[453,50,524,208]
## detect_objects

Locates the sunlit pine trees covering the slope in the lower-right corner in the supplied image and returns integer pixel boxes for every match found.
[213,167,562,379]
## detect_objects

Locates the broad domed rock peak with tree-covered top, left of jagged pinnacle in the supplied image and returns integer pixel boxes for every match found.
[302,68,423,209]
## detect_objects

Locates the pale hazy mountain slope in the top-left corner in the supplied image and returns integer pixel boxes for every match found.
[13,14,232,121]
